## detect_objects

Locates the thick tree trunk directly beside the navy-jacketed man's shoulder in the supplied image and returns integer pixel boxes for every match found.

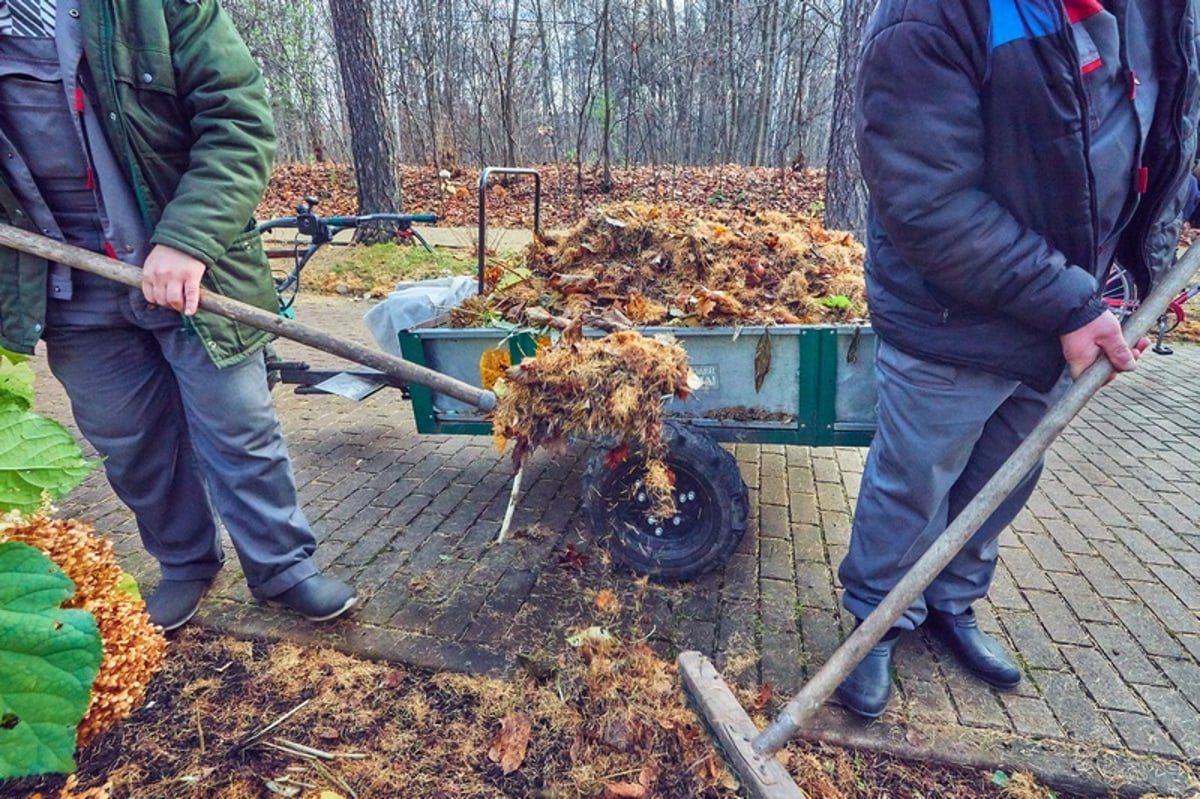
[824,0,875,239]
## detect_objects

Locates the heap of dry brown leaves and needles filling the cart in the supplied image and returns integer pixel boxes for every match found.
[451,203,866,328]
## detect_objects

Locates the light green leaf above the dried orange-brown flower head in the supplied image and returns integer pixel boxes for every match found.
[0,404,96,511]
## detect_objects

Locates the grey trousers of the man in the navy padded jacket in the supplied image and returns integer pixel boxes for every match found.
[838,341,1070,629]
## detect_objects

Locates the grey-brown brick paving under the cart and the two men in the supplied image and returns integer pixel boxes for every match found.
[35,296,1200,795]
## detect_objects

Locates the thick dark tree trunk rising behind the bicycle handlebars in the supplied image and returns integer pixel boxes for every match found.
[329,0,400,244]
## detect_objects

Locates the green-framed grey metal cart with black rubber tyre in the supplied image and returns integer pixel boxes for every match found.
[400,320,876,579]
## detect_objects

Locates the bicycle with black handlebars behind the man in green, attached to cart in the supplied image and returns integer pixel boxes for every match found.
[258,197,438,391]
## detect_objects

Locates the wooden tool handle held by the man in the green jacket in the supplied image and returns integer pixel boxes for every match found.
[0,223,496,411]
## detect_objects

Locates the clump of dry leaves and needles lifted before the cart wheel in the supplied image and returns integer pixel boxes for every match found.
[491,328,698,516]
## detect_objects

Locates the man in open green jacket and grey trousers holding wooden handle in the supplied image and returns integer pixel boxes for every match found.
[0,0,355,630]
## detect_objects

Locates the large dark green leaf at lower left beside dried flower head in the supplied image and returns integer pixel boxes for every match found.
[0,541,102,779]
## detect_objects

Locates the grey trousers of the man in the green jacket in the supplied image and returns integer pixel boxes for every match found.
[43,290,317,599]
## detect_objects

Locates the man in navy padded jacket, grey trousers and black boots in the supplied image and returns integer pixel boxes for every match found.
[838,0,1200,717]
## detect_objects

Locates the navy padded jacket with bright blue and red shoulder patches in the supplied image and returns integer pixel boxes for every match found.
[857,0,1200,391]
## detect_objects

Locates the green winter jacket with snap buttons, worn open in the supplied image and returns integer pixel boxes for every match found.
[0,0,278,366]
